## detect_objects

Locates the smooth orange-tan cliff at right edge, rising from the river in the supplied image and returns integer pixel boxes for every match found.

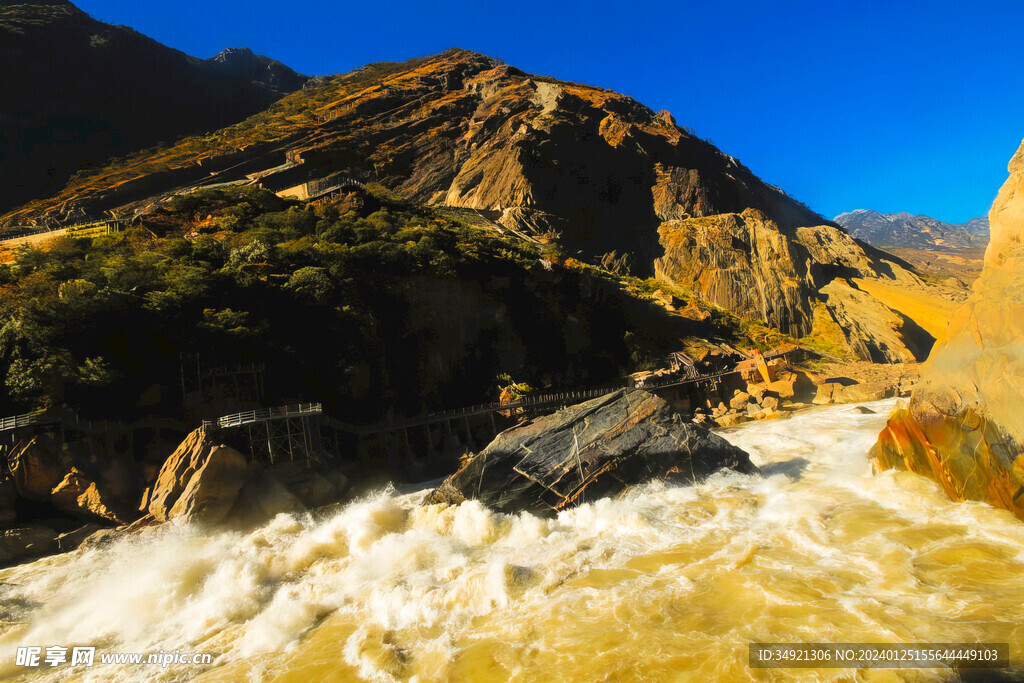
[872,145,1024,519]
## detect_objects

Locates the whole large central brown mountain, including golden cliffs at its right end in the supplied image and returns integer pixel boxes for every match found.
[0,49,950,361]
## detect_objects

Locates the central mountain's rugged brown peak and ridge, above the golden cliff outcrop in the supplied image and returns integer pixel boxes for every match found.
[2,50,823,242]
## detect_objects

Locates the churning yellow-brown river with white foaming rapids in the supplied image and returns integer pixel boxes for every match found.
[0,401,1024,683]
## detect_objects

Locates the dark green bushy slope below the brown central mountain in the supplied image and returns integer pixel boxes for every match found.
[0,187,790,420]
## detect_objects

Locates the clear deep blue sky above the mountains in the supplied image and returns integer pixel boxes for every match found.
[77,0,1024,222]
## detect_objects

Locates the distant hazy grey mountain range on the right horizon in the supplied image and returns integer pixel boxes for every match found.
[835,209,988,250]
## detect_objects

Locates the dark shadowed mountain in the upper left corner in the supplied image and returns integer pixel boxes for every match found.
[0,0,306,216]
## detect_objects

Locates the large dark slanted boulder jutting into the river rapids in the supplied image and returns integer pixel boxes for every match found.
[425,389,758,513]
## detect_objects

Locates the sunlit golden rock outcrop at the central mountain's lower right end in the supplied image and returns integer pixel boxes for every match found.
[654,209,934,362]
